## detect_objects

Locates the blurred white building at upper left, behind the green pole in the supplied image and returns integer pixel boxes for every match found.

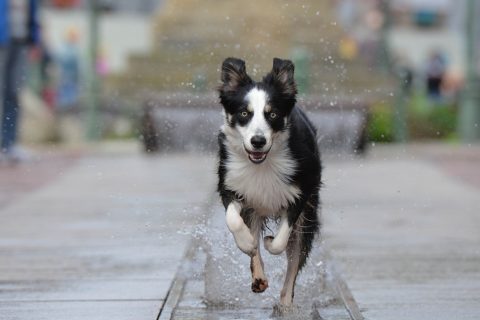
[42,0,164,72]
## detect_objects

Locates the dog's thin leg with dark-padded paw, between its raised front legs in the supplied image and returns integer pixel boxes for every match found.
[249,216,268,293]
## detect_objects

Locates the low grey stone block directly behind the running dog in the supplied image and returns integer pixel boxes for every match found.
[140,93,368,153]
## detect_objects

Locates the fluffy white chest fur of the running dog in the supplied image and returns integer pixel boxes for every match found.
[225,129,300,215]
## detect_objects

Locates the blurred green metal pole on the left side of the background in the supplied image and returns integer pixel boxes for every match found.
[87,0,100,141]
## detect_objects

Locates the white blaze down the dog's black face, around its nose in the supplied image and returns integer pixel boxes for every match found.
[238,88,272,150]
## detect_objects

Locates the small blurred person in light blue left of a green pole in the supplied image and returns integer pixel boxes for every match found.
[57,28,80,109]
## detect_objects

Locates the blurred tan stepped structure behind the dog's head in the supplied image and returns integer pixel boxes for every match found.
[108,0,389,101]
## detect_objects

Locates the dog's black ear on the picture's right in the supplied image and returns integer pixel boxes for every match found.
[266,58,297,98]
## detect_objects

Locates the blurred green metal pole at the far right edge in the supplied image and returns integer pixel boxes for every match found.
[459,0,480,142]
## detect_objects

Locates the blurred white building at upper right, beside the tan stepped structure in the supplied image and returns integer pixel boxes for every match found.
[338,0,480,82]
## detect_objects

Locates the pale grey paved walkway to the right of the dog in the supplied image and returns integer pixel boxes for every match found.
[322,145,480,320]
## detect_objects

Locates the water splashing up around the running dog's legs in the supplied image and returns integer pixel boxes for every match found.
[194,202,333,312]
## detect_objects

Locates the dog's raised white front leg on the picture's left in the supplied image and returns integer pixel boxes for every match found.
[226,201,257,256]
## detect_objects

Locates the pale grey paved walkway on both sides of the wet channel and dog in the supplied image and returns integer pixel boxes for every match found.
[0,146,480,320]
